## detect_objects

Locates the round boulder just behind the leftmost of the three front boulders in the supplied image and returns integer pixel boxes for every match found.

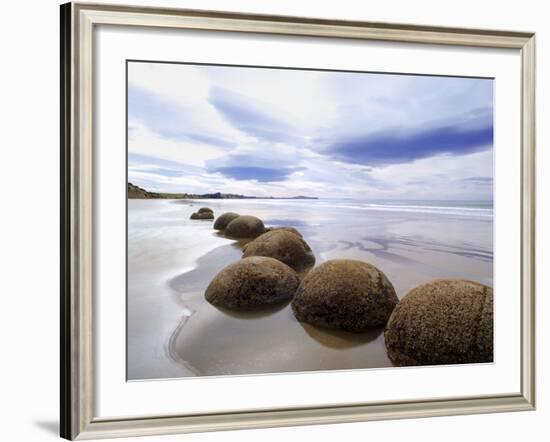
[243,229,315,271]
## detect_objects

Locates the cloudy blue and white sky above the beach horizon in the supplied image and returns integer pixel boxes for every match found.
[128,62,493,200]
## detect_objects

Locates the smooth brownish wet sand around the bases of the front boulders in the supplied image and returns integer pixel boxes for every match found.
[170,238,391,375]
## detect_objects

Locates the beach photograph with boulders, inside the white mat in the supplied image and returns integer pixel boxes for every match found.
[125,61,494,381]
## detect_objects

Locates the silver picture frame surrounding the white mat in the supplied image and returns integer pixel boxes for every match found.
[60,3,535,440]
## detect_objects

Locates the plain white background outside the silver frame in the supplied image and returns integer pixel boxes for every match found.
[0,0,550,441]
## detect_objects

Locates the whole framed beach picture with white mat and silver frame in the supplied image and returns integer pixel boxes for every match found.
[61,3,535,440]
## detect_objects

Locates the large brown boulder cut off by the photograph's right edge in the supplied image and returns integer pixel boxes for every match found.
[384,279,493,366]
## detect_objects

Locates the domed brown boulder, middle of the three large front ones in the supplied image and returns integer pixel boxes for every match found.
[292,259,398,333]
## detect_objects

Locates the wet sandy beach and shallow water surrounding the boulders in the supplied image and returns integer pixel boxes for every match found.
[127,199,493,380]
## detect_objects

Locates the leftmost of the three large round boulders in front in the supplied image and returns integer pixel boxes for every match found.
[205,256,300,310]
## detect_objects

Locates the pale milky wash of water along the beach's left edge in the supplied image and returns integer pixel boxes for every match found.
[127,200,244,380]
